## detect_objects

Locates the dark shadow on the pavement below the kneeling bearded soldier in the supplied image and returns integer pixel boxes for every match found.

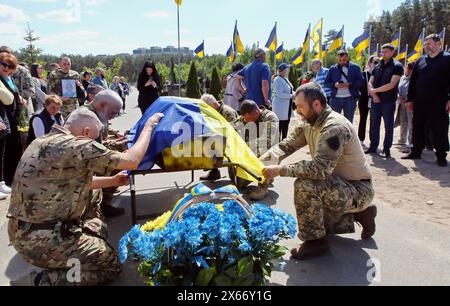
[284,236,378,286]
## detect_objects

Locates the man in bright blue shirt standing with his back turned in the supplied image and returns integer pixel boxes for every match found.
[236,48,272,108]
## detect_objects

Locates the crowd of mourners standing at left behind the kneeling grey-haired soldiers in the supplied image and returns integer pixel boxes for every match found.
[0,46,130,200]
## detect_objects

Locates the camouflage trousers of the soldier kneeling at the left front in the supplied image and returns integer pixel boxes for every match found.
[8,191,121,286]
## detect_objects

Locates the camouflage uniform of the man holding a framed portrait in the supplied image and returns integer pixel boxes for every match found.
[48,68,80,119]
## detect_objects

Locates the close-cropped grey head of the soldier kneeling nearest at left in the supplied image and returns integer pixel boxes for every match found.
[64,107,103,139]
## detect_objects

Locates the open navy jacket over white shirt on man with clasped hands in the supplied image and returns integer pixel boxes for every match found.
[325,62,364,98]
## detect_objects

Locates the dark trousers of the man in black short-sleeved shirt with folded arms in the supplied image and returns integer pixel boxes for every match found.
[370,103,396,151]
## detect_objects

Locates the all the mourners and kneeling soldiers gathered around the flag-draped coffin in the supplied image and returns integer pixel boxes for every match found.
[0,35,450,285]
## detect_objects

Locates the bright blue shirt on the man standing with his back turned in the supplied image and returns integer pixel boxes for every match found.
[238,60,272,106]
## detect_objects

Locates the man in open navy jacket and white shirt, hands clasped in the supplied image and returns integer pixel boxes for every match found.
[325,50,364,123]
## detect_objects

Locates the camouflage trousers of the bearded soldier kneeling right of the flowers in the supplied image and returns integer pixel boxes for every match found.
[294,176,374,241]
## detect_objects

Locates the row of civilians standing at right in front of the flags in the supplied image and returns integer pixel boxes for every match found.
[224,34,450,167]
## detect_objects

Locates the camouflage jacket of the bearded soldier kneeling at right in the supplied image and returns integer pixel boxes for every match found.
[260,106,372,181]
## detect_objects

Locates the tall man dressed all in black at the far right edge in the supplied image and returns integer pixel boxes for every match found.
[403,34,450,167]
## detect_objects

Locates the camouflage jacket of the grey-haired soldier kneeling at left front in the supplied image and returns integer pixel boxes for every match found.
[9,126,121,223]
